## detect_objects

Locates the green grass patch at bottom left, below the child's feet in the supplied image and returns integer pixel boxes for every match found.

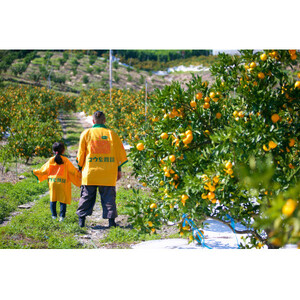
[0,191,86,249]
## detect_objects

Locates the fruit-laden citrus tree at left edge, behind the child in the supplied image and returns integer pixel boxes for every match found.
[0,86,76,163]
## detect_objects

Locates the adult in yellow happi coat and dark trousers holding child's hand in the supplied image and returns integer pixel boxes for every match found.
[76,111,127,227]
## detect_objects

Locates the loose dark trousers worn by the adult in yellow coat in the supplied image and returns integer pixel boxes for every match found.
[76,185,118,219]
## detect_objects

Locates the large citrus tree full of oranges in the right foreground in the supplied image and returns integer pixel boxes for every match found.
[131,50,300,248]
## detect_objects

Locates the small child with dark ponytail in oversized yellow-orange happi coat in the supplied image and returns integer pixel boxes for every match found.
[32,142,81,221]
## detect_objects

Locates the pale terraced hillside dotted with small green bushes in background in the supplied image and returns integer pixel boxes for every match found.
[0,51,216,94]
